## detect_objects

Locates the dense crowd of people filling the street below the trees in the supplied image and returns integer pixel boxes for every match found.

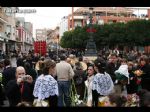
[0,49,150,107]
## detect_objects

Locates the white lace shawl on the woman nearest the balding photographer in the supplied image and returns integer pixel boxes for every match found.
[33,75,58,100]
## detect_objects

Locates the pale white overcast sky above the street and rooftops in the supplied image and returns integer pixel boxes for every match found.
[16,7,147,38]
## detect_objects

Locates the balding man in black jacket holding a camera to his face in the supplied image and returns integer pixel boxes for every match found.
[6,66,34,106]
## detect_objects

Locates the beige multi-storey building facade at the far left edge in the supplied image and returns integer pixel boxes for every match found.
[0,7,17,54]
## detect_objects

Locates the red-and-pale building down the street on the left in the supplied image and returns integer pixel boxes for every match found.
[16,17,33,53]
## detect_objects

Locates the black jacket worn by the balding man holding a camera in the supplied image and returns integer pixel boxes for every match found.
[6,80,34,106]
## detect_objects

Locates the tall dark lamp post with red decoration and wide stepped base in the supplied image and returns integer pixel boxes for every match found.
[85,7,97,56]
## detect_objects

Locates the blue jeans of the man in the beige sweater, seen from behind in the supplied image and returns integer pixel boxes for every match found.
[58,81,71,107]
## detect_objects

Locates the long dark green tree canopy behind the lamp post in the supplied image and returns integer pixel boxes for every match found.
[60,20,150,48]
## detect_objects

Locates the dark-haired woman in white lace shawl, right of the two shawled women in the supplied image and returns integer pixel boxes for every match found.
[92,59,114,107]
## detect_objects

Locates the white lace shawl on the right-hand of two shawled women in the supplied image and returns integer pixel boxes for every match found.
[92,72,114,95]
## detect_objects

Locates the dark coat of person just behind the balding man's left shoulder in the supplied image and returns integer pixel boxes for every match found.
[2,67,16,88]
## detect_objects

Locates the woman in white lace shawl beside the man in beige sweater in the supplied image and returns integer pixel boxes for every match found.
[33,59,58,106]
